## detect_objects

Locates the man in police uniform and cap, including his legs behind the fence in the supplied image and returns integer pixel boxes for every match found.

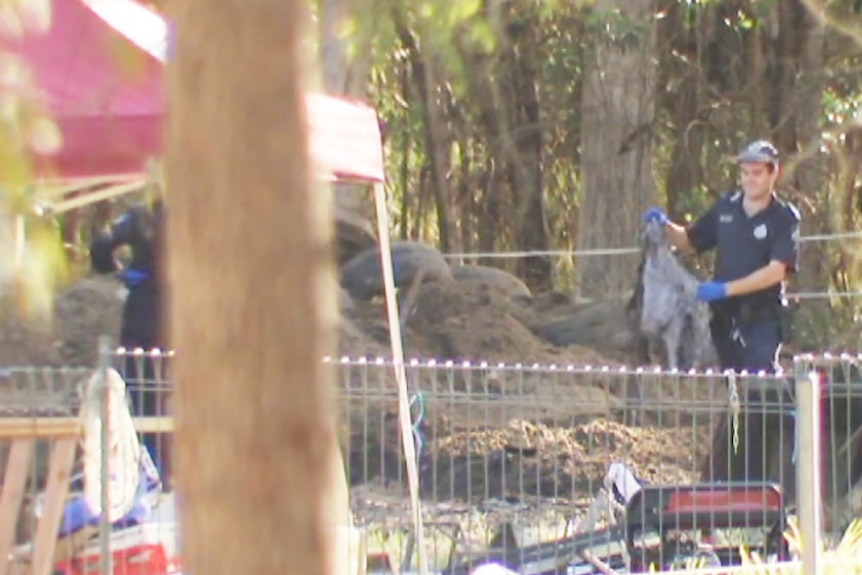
[644,140,801,492]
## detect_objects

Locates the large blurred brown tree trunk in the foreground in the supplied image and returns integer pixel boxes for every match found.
[166,0,344,575]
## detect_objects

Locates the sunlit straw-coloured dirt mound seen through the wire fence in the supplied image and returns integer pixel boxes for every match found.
[347,410,710,502]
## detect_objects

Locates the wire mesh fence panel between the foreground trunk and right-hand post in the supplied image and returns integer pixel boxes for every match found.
[339,360,793,573]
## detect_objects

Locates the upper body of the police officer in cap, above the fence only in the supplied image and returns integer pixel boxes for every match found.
[644,140,801,373]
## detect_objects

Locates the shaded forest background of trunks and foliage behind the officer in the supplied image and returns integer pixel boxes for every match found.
[314,0,862,347]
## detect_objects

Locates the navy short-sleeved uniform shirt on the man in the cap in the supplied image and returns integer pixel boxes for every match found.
[688,191,801,304]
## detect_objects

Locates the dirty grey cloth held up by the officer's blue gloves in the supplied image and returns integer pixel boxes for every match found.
[640,218,716,369]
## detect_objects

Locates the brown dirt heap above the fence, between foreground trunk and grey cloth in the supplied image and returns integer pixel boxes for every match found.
[339,278,630,365]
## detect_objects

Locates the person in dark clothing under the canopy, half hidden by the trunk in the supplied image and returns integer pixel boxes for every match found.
[90,201,170,486]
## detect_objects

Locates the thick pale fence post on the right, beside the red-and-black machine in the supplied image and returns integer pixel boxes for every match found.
[794,359,821,575]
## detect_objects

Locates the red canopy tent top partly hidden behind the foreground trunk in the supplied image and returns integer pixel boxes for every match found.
[0,0,384,190]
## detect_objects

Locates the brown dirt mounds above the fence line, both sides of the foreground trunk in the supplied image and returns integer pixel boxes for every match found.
[0,252,631,366]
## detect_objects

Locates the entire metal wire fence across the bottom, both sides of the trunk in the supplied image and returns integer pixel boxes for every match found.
[0,352,862,575]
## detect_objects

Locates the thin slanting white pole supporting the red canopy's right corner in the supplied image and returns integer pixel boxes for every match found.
[374,182,428,575]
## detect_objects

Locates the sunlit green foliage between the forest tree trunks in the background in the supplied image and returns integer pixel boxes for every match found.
[328,0,862,347]
